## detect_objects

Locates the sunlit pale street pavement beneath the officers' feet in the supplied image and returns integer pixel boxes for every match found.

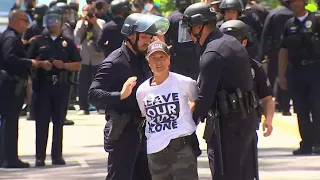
[0,111,320,180]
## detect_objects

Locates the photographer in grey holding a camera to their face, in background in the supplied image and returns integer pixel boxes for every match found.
[74,5,105,115]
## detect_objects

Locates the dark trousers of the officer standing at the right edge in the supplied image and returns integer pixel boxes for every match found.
[291,78,320,148]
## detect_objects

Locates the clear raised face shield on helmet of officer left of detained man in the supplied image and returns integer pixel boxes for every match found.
[135,14,170,36]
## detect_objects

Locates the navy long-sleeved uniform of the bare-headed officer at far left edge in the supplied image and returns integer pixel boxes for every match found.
[0,27,32,167]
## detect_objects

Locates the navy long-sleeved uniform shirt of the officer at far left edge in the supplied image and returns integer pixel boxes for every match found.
[0,27,32,79]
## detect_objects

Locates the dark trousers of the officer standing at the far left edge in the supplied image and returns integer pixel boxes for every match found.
[0,81,26,163]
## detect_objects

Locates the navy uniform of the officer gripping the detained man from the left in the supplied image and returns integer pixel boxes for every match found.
[89,43,151,180]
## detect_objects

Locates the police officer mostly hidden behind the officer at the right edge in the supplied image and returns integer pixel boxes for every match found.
[260,0,293,115]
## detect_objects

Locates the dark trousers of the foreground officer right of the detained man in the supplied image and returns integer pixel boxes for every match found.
[208,111,257,180]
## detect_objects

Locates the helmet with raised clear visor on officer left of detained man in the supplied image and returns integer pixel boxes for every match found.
[121,13,170,36]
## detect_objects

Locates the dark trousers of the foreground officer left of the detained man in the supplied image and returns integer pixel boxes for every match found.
[105,121,151,180]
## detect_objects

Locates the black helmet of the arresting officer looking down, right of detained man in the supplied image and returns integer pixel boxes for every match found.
[182,3,217,27]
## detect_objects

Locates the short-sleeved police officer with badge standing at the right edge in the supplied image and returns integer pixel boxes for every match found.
[279,0,320,155]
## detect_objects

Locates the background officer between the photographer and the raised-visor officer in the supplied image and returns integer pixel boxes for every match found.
[97,0,132,57]
